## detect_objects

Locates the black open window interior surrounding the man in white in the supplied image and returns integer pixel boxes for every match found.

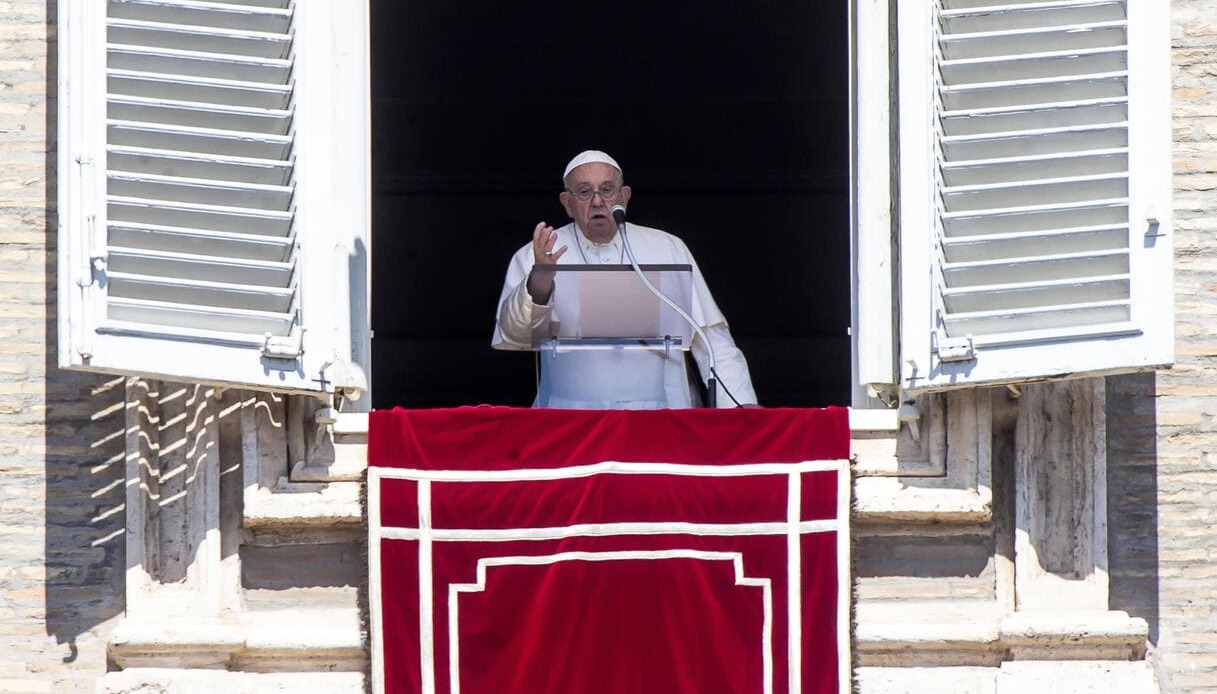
[371,0,852,408]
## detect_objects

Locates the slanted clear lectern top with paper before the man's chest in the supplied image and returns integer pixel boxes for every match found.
[534,264,692,349]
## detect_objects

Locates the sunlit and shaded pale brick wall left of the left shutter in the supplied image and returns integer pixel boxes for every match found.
[0,0,124,692]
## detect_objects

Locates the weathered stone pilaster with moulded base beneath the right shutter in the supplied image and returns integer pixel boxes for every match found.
[999,379,1148,662]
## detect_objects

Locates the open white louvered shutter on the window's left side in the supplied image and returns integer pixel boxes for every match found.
[60,0,368,391]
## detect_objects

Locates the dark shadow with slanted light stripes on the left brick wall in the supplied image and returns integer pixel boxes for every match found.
[41,2,125,664]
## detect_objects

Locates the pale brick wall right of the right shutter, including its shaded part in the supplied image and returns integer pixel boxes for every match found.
[1107,0,1217,694]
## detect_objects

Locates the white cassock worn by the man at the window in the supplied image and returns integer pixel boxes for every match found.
[490,223,757,409]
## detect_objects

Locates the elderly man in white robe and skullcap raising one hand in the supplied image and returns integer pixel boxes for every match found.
[492,150,757,409]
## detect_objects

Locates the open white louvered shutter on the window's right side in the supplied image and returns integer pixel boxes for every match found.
[898,0,1173,391]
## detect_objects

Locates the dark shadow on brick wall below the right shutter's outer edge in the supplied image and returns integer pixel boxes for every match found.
[1106,373,1159,645]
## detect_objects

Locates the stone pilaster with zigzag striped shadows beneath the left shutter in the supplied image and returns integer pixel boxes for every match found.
[111,379,240,667]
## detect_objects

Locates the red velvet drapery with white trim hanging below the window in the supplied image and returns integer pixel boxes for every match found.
[369,407,849,694]
